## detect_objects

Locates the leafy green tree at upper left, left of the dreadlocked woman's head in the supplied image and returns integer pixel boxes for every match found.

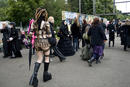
[7,0,39,26]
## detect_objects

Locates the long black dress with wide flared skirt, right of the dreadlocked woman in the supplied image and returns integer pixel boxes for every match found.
[57,24,75,56]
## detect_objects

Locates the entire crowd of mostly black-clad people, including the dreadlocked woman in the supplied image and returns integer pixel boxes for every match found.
[1,8,130,87]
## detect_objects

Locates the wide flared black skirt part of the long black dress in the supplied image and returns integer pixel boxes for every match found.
[57,38,75,56]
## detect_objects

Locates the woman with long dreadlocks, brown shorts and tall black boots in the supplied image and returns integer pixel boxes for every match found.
[29,8,52,87]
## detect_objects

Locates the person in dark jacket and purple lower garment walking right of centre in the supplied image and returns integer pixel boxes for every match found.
[88,18,107,66]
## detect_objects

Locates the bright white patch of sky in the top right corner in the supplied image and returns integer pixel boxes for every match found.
[115,0,130,12]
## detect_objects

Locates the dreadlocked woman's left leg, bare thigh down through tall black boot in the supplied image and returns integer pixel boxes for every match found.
[29,51,43,87]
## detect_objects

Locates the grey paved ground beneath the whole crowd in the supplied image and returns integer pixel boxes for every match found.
[0,38,130,87]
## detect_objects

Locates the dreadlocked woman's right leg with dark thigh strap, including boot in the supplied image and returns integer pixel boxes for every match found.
[43,50,52,82]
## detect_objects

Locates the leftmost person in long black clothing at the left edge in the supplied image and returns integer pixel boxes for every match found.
[1,23,11,58]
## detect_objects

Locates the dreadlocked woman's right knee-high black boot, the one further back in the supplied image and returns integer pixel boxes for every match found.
[43,62,52,82]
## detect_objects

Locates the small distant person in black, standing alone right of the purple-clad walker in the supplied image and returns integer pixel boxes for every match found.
[107,21,115,47]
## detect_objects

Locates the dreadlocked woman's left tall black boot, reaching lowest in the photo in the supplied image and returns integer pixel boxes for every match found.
[29,62,41,87]
